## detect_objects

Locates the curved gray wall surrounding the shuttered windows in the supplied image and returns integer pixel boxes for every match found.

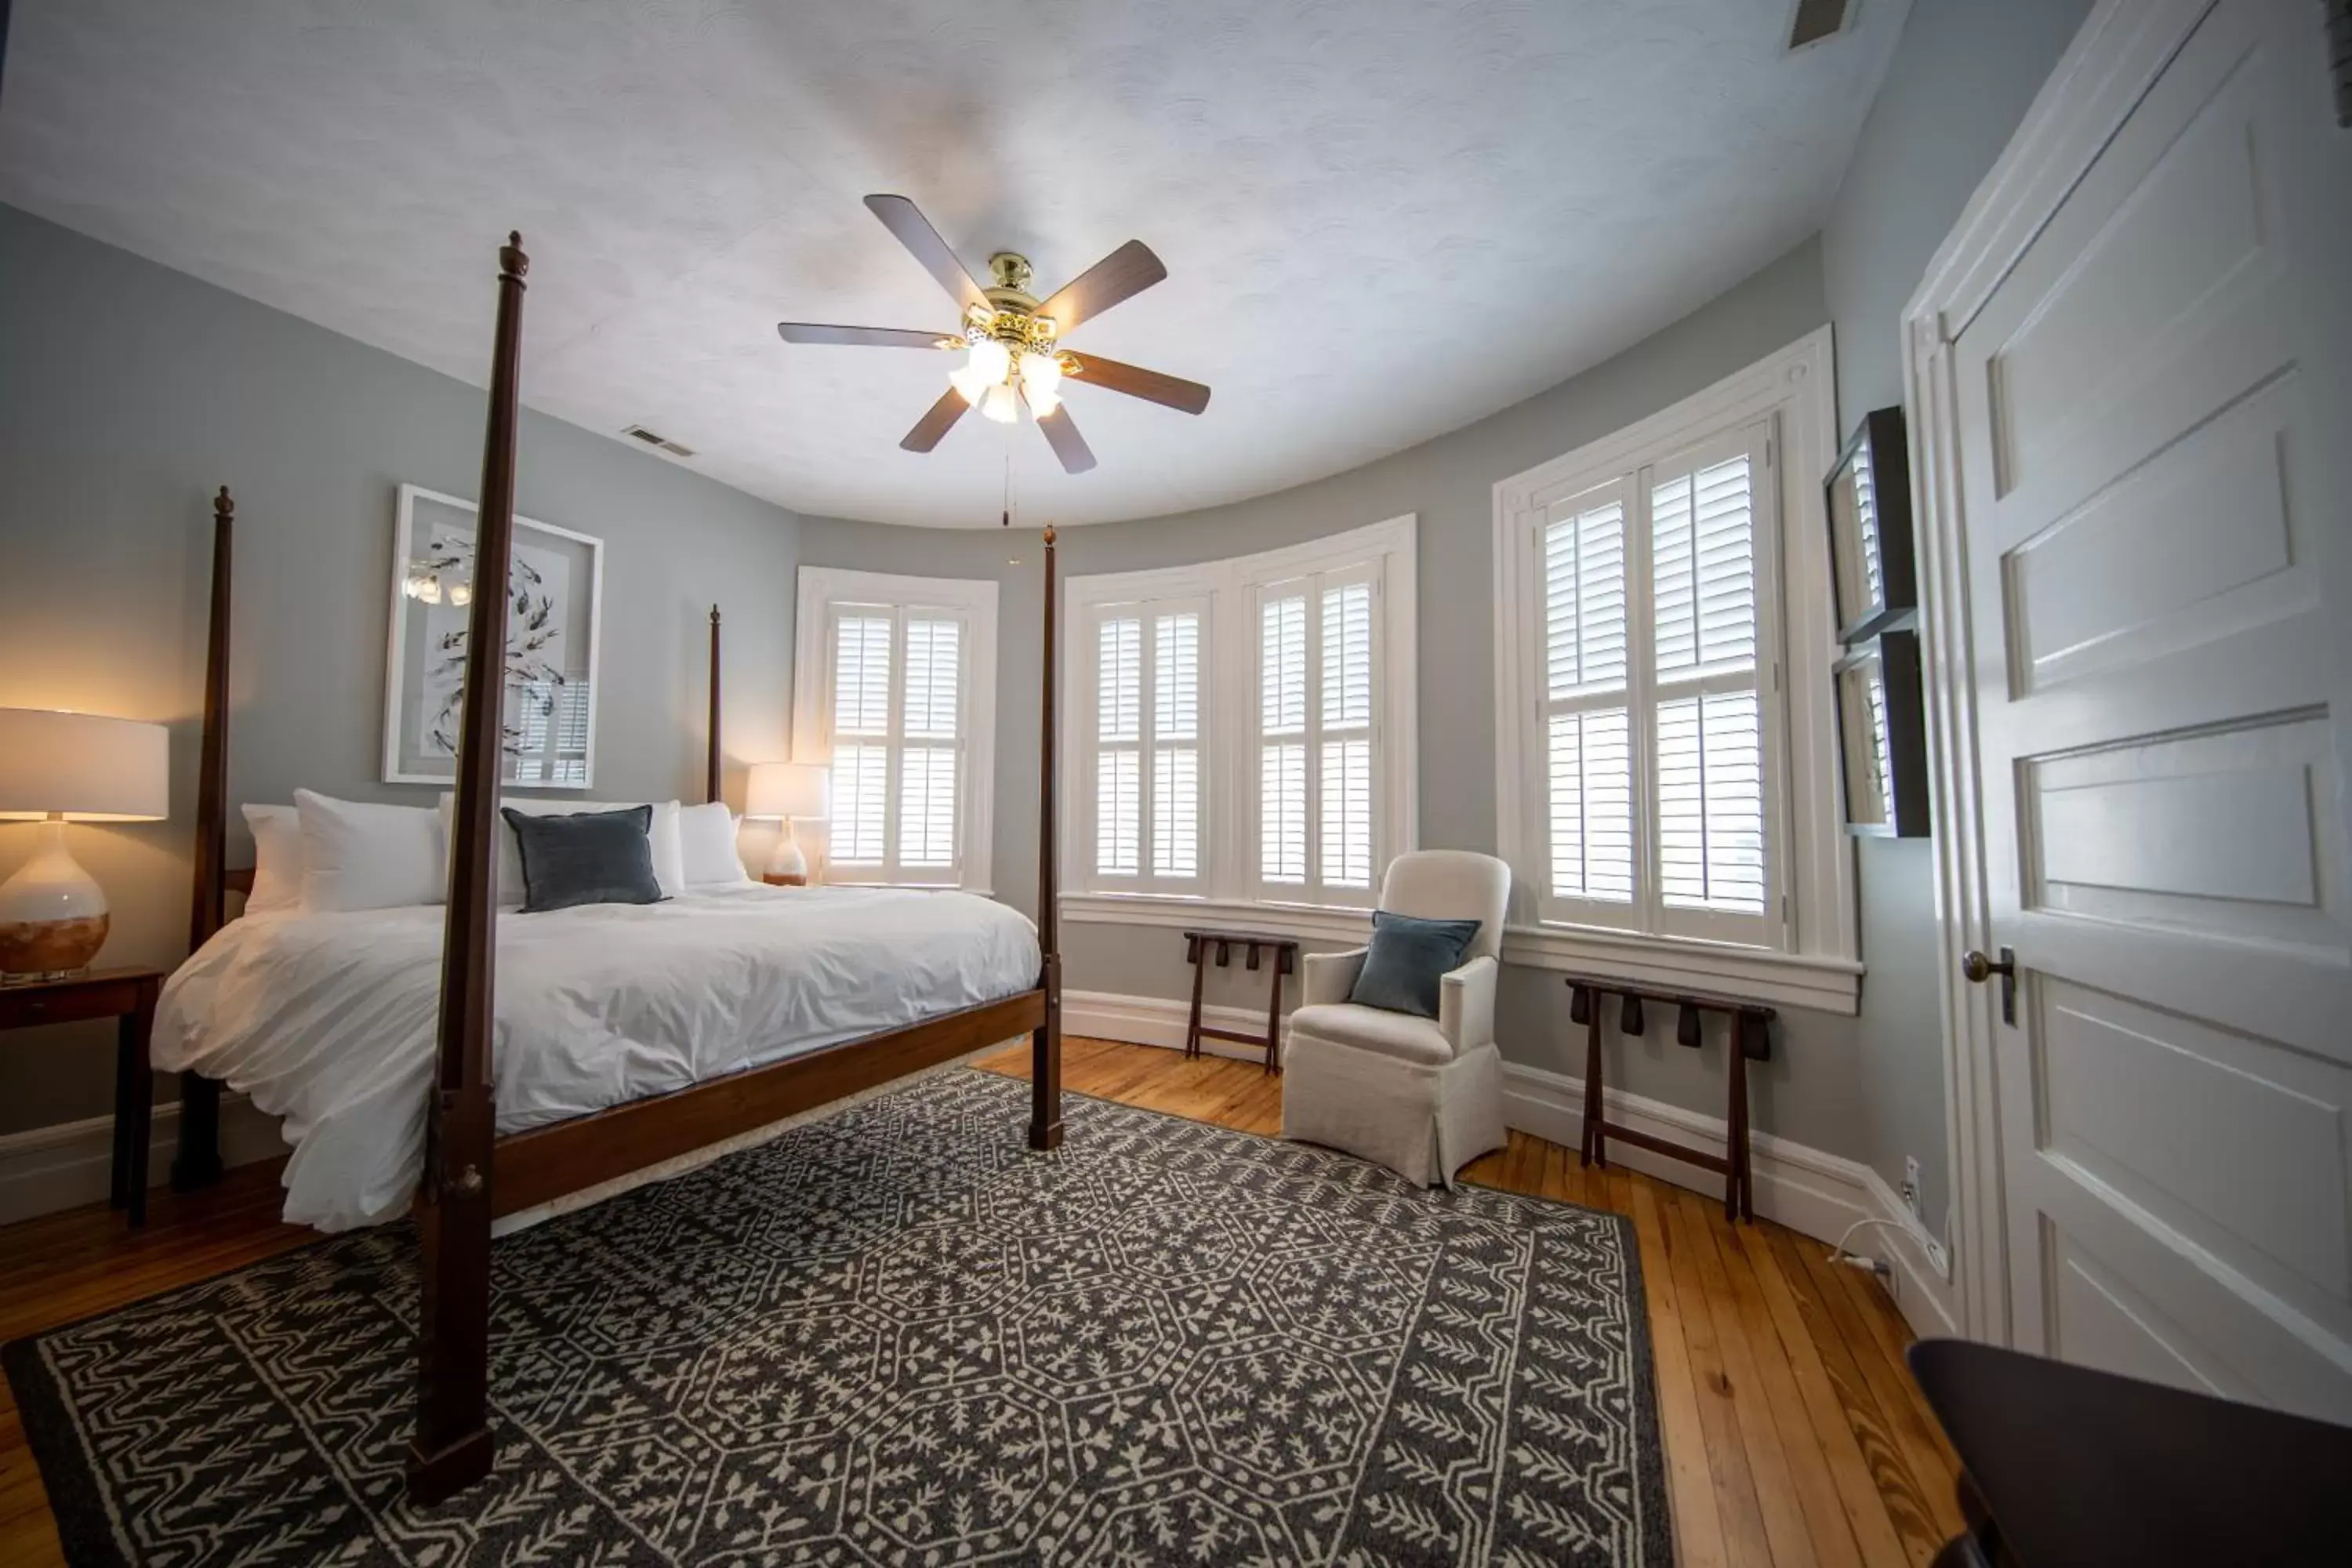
[800,242,1872,1154]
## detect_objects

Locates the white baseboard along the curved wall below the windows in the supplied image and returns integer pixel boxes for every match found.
[1061,992,1957,1335]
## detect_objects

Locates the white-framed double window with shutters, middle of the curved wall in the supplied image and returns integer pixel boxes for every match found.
[1065,517,1414,919]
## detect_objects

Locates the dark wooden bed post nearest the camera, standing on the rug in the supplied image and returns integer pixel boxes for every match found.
[409,233,532,1504]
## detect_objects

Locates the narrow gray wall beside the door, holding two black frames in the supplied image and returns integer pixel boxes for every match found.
[1820,0,2089,1234]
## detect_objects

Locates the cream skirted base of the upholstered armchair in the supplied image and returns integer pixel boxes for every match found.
[1282,1029,1508,1187]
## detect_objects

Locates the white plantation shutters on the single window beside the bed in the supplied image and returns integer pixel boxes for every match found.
[828,604,969,884]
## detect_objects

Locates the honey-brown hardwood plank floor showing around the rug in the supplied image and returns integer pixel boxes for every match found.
[0,1039,1962,1568]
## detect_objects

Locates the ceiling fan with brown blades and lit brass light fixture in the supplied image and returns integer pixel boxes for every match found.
[776,195,1209,473]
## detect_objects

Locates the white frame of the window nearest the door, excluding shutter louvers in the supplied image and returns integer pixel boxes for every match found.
[1494,327,1863,1015]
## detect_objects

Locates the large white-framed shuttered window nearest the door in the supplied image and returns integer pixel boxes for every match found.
[1496,334,1860,1013]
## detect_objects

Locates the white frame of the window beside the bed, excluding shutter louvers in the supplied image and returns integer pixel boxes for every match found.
[793,567,997,895]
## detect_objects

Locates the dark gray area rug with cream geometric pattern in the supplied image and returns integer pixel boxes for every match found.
[7,1069,1672,1566]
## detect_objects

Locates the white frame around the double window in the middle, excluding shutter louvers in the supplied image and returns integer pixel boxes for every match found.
[1061,515,1421,928]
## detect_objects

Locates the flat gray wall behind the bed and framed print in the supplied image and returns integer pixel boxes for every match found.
[0,207,797,1133]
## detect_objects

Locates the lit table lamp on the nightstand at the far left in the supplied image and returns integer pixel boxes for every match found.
[0,708,172,985]
